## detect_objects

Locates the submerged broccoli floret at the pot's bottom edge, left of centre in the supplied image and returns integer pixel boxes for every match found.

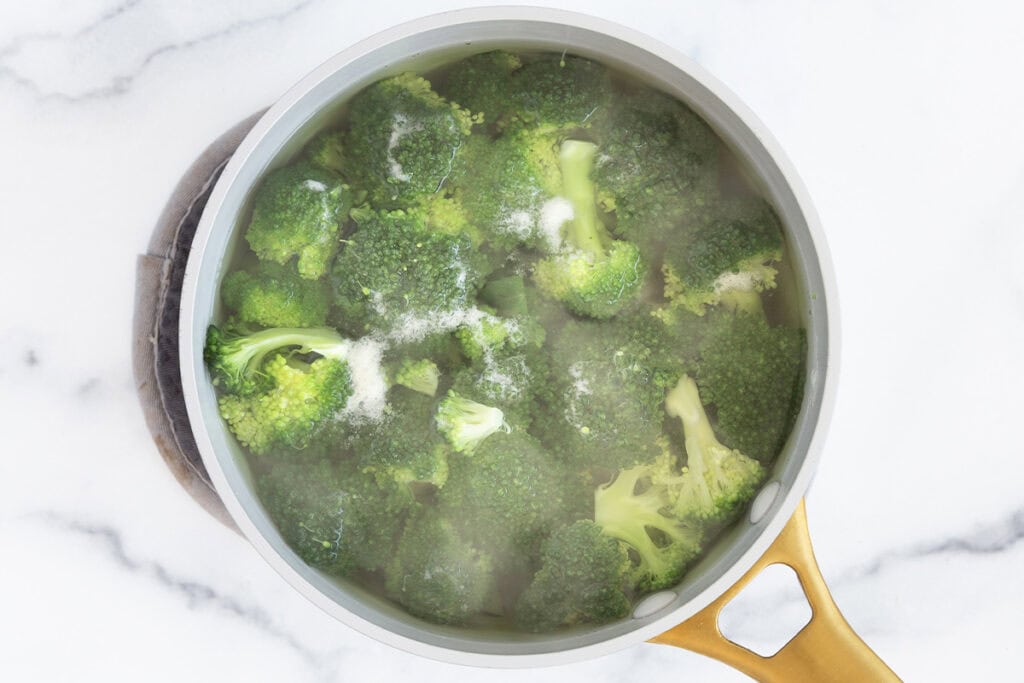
[385,509,495,624]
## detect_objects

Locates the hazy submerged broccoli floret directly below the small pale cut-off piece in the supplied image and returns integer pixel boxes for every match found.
[437,430,578,567]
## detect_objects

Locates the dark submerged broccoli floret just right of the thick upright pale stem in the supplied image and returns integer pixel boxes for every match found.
[594,89,719,249]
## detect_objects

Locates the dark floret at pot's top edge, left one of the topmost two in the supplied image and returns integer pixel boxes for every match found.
[444,50,522,130]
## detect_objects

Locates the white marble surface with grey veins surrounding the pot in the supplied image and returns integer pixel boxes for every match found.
[0,0,1024,683]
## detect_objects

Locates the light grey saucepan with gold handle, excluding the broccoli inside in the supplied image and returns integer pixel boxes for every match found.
[180,7,898,681]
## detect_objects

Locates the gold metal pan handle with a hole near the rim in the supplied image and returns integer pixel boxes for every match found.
[650,501,900,683]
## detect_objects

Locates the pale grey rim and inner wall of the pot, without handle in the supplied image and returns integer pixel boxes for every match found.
[181,8,835,666]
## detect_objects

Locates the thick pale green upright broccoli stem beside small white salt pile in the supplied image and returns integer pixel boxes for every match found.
[558,140,611,260]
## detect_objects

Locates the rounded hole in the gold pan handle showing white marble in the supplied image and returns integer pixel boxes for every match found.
[718,564,811,657]
